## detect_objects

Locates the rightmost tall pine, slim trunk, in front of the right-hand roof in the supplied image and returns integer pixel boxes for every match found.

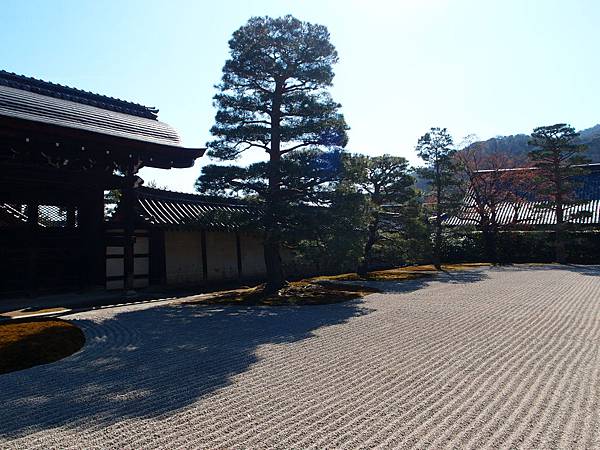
[529,123,589,263]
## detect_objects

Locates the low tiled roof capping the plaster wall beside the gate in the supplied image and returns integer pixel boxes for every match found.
[136,187,260,229]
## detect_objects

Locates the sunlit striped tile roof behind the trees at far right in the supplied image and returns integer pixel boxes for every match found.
[444,164,600,226]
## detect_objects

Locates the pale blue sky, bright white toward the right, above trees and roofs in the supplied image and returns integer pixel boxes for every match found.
[0,0,600,191]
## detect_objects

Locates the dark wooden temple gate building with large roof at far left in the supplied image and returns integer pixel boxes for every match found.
[0,71,204,295]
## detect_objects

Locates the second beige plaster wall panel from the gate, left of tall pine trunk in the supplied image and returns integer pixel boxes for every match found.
[206,231,238,281]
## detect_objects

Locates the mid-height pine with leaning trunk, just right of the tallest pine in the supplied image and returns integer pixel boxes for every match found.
[346,155,416,275]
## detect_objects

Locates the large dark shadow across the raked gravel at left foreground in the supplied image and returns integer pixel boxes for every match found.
[0,300,369,439]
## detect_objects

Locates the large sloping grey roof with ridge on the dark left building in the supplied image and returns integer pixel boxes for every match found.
[0,71,186,147]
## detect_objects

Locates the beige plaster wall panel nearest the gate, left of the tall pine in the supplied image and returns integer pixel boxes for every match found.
[165,231,203,284]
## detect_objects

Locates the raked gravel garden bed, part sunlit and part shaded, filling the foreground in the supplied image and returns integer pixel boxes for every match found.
[0,266,600,448]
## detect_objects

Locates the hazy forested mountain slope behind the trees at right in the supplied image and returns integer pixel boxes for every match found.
[466,124,600,165]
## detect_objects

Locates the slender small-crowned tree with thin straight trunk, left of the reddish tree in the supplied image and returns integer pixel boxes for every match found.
[416,128,455,270]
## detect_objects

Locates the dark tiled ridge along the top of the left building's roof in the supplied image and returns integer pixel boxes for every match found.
[0,69,158,119]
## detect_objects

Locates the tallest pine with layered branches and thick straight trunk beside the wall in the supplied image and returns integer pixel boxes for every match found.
[198,15,348,292]
